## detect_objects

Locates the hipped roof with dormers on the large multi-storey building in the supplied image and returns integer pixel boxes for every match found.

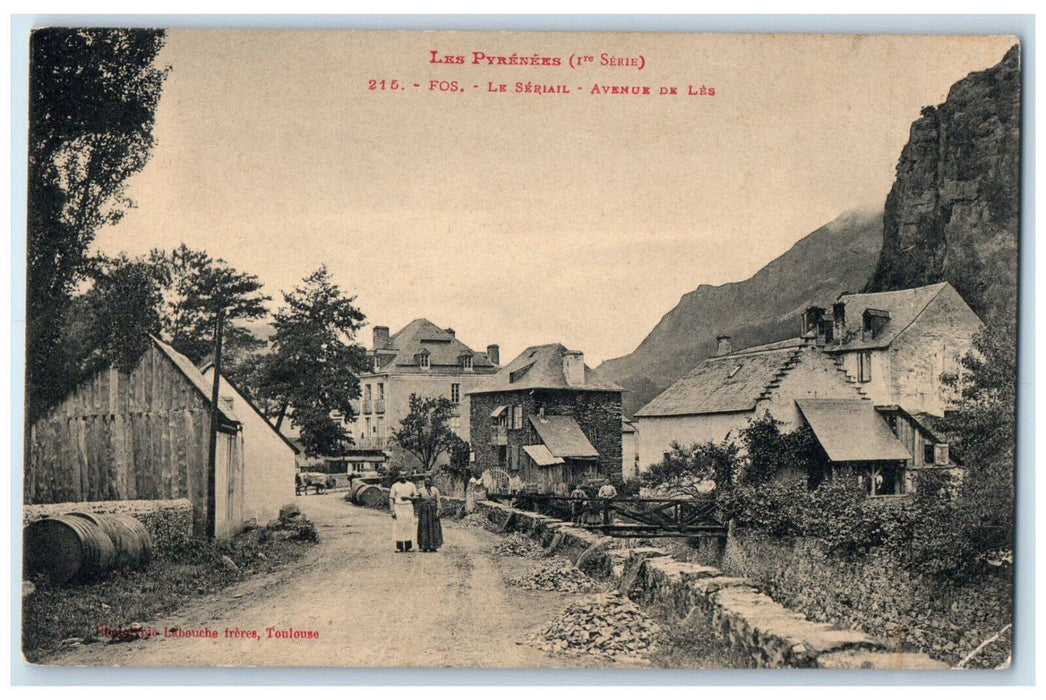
[371,318,498,372]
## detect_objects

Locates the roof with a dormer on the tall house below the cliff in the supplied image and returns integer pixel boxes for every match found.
[824,281,949,353]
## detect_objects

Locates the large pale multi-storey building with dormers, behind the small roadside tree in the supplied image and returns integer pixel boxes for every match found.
[345,318,499,471]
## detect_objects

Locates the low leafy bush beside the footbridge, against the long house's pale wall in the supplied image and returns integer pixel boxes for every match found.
[641,439,737,496]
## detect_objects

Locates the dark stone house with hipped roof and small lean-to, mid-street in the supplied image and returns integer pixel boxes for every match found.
[469,343,622,493]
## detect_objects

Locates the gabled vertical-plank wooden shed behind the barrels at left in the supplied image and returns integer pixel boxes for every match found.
[23,338,245,539]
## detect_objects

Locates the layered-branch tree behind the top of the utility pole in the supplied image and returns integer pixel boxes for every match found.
[150,244,271,371]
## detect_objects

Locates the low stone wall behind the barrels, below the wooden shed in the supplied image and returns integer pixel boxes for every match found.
[22,498,192,555]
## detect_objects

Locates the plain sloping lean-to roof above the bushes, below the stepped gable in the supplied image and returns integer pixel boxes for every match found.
[795,399,912,461]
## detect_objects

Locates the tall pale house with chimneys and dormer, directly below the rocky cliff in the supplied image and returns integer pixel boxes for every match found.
[802,283,984,416]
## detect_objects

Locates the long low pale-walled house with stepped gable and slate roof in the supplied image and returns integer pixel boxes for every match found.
[634,336,871,471]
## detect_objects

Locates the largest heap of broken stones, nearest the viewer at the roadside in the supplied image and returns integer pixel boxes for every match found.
[530,591,662,661]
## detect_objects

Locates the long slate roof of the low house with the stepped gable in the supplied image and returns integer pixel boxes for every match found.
[636,338,804,417]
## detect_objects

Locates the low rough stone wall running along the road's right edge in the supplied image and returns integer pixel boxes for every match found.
[477,501,948,670]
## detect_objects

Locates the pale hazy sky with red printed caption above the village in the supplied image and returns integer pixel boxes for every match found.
[95,29,1016,366]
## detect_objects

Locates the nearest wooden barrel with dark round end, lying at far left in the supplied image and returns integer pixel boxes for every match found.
[22,516,116,583]
